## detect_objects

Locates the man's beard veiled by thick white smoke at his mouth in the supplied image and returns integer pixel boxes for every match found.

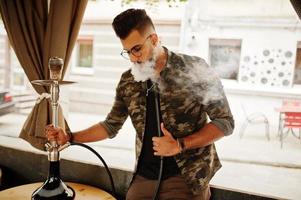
[131,46,159,82]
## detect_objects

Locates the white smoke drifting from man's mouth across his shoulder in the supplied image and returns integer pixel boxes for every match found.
[131,46,223,105]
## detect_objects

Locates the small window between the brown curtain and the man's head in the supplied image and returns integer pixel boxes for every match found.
[72,37,93,73]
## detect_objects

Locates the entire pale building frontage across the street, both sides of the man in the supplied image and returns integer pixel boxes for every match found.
[0,0,301,134]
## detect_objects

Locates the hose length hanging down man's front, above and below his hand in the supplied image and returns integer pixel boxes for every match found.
[153,90,163,200]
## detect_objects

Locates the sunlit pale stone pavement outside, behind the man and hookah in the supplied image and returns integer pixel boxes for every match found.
[0,113,301,200]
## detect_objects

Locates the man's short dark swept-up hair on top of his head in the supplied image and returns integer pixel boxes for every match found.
[112,8,155,39]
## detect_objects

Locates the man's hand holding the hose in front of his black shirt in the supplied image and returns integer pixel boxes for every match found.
[152,123,181,156]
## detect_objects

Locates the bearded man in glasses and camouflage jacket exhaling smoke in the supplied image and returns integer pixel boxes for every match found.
[46,9,234,200]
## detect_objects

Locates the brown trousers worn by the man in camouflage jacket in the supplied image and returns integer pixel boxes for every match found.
[126,175,211,200]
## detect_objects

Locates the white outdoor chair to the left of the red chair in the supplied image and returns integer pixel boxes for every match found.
[239,105,270,140]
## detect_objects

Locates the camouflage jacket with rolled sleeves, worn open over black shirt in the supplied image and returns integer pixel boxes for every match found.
[101,48,234,194]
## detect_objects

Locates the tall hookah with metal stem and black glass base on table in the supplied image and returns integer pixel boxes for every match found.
[31,57,75,200]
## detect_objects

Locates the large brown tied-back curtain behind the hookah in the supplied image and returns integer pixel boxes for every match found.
[0,0,87,150]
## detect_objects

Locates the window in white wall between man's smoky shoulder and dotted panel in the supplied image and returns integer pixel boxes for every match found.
[209,39,241,80]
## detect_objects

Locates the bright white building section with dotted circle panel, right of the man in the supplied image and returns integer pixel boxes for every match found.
[180,0,301,132]
